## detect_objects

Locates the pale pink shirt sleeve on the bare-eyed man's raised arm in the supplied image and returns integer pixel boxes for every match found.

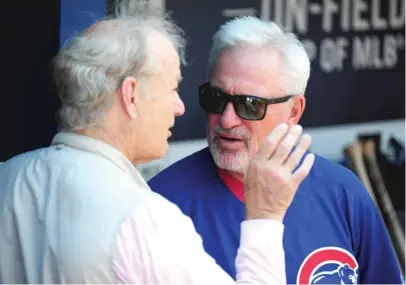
[113,194,286,285]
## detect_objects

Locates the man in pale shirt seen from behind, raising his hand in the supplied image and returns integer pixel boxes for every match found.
[0,1,313,285]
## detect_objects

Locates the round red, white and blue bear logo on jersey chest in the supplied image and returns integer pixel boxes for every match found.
[296,247,358,284]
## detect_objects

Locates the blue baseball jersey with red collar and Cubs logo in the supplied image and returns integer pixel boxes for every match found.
[149,148,402,284]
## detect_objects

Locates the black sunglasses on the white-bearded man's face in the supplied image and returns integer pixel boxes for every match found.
[199,82,293,121]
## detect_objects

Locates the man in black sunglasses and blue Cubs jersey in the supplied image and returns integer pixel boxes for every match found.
[149,17,402,284]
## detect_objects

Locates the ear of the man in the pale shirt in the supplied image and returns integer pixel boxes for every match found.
[119,76,139,120]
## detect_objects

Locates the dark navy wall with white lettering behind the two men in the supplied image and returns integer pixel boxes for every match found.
[160,0,405,140]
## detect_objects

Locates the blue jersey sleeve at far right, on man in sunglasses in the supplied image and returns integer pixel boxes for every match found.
[350,181,403,284]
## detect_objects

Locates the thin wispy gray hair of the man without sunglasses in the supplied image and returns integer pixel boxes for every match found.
[53,0,186,130]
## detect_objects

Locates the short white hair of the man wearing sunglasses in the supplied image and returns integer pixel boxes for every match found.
[208,16,310,95]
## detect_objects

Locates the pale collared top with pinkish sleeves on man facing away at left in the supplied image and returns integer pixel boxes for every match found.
[0,133,286,284]
